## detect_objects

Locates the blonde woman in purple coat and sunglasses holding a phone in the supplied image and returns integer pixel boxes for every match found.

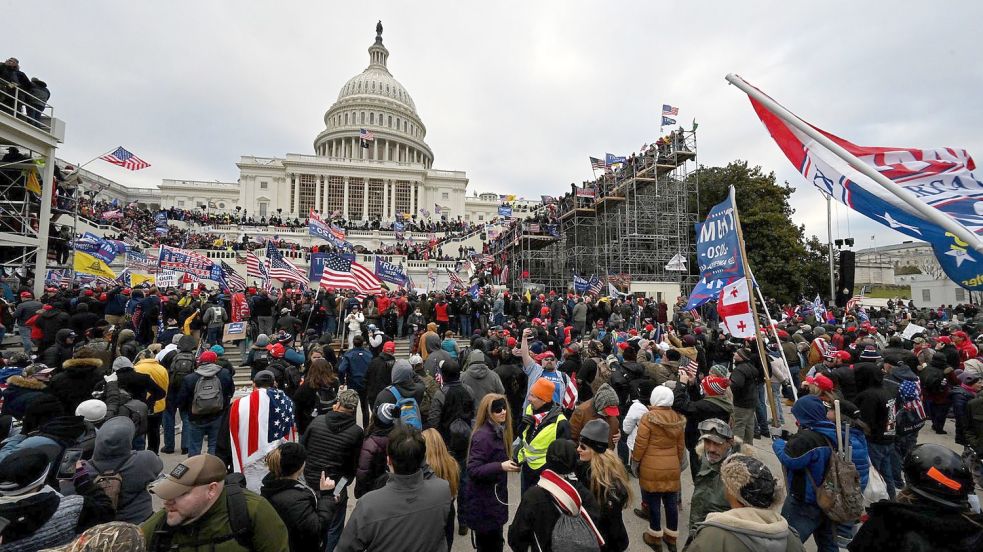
[460,393,519,552]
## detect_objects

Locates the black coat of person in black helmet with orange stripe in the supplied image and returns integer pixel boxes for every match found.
[847,500,983,552]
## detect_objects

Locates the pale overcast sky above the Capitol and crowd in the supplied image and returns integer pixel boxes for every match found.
[9,0,983,247]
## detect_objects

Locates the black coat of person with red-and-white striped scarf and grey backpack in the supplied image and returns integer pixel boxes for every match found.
[507,472,601,552]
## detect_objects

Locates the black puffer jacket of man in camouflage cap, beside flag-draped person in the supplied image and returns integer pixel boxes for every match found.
[300,411,364,488]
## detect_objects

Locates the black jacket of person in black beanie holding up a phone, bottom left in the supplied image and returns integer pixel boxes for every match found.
[260,473,338,552]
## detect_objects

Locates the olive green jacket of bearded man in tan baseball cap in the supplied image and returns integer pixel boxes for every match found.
[140,489,289,552]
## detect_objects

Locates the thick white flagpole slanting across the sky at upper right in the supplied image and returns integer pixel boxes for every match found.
[725,73,983,253]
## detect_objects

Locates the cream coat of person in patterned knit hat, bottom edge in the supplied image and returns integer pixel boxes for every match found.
[686,508,805,552]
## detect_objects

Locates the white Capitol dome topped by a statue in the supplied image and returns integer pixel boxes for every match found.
[314,22,433,168]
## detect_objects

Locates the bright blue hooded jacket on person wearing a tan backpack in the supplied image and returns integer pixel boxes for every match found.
[771,395,870,504]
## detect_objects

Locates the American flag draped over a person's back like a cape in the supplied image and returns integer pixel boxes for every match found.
[229,389,297,473]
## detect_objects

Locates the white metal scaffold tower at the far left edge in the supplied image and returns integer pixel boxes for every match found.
[0,84,65,296]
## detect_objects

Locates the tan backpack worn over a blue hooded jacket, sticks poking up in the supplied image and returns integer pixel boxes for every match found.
[805,408,864,523]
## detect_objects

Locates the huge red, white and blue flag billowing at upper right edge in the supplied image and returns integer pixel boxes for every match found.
[749,81,983,290]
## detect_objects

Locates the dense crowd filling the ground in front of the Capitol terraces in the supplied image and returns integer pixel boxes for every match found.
[0,282,983,552]
